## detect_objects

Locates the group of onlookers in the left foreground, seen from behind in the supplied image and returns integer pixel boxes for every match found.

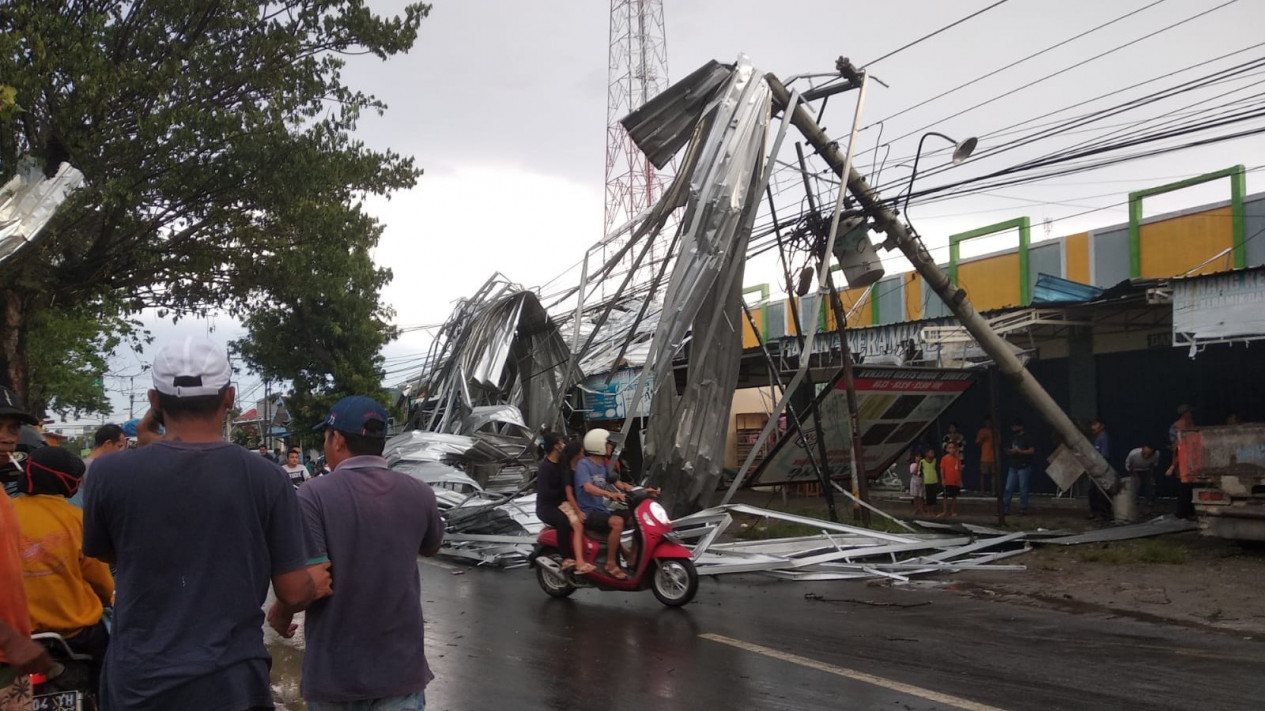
[0,338,444,711]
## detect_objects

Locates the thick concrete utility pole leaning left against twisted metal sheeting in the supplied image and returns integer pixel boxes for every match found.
[765,73,1117,495]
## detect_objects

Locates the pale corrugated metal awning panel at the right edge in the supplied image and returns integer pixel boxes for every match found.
[1173,269,1265,345]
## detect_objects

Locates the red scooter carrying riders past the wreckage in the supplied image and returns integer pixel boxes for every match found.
[528,490,698,607]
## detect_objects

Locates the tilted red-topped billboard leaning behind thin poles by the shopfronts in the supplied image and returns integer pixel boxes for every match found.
[748,367,975,486]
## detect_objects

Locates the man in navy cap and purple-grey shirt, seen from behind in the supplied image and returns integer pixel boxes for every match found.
[268,395,444,711]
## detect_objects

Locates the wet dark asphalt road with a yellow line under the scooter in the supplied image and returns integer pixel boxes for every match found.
[273,560,1265,711]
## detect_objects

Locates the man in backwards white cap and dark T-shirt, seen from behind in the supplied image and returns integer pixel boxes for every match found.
[83,338,316,711]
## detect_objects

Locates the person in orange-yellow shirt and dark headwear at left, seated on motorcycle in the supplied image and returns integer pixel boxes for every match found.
[13,447,114,659]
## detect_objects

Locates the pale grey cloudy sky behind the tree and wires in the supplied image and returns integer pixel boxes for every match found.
[79,0,1265,425]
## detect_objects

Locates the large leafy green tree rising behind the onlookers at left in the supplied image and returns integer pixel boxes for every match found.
[0,0,428,412]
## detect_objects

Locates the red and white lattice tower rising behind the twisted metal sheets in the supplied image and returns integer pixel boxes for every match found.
[603,0,668,282]
